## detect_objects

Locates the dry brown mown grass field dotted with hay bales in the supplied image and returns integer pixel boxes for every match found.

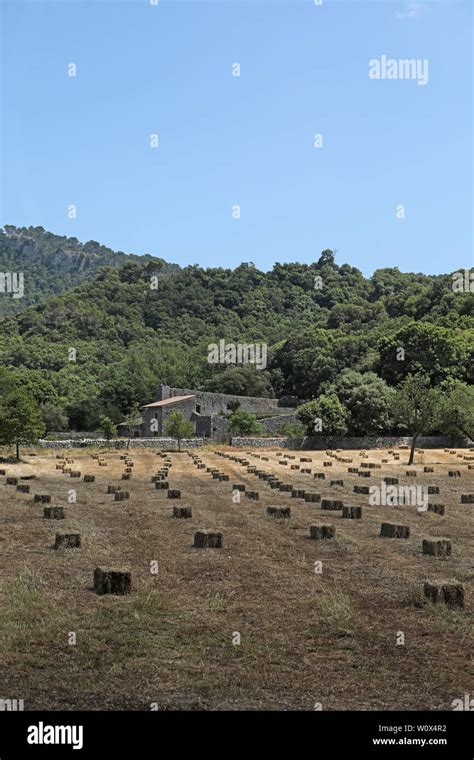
[0,447,474,710]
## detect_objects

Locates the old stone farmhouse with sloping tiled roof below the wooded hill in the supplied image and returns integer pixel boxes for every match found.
[118,385,296,440]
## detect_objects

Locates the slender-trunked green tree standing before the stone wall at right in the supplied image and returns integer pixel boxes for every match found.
[393,375,441,465]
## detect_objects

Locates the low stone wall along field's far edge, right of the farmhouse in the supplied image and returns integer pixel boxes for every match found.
[232,436,472,451]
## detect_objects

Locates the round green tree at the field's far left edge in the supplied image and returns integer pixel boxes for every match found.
[0,388,45,460]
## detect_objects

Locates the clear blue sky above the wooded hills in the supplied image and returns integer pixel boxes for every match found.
[0,0,473,274]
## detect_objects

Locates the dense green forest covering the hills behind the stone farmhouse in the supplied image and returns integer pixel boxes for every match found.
[0,227,474,433]
